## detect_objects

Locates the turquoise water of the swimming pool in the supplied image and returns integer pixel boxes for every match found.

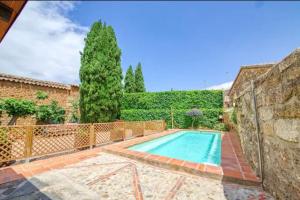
[128,131,221,165]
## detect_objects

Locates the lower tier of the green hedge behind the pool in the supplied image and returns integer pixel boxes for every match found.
[121,108,223,128]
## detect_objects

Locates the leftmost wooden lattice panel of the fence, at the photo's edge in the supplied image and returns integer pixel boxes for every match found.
[0,126,27,162]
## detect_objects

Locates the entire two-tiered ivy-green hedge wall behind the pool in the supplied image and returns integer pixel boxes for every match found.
[121,90,223,129]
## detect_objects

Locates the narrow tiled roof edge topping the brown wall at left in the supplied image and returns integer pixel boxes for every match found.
[0,73,78,89]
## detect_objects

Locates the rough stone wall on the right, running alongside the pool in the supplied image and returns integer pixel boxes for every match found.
[234,49,300,200]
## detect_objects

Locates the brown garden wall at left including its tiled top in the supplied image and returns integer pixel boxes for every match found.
[0,74,79,125]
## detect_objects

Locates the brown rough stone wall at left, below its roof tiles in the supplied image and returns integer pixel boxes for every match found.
[0,80,79,125]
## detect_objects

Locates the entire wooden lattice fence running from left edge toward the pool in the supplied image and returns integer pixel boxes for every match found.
[0,120,166,163]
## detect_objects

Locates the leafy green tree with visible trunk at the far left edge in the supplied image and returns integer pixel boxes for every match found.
[1,98,36,125]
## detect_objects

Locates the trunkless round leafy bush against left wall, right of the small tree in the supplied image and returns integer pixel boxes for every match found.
[36,101,65,124]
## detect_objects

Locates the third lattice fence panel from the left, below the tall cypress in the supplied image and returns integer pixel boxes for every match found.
[94,123,113,144]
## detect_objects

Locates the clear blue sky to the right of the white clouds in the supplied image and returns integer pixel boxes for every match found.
[69,2,300,91]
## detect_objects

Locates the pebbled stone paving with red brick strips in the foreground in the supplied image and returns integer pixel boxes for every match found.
[0,152,273,200]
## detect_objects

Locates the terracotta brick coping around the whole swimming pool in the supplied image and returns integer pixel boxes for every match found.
[102,129,261,186]
